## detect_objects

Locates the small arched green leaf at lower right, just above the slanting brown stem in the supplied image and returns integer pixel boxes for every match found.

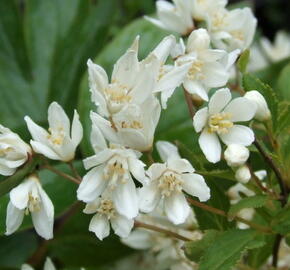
[228,195,268,217]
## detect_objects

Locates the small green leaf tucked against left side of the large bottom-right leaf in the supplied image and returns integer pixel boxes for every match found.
[185,230,221,263]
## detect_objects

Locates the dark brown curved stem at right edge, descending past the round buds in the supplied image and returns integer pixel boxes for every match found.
[254,140,287,206]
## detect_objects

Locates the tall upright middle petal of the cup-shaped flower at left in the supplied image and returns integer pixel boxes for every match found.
[48,102,70,134]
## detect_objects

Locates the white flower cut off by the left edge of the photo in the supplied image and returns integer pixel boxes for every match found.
[0,125,31,176]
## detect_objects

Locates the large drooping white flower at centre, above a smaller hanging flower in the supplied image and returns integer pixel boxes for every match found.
[77,119,147,219]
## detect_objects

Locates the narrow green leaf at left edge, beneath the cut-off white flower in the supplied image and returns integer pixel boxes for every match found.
[0,156,39,197]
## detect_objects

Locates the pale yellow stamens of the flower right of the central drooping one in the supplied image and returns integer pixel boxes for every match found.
[158,171,183,197]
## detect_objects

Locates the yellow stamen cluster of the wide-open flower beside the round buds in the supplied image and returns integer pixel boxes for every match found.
[208,112,234,134]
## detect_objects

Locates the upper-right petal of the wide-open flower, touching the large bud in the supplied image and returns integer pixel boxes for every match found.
[224,97,257,122]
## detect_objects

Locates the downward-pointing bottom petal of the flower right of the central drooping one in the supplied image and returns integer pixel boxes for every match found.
[164,192,190,225]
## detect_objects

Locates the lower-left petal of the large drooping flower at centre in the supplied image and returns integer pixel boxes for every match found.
[77,166,108,203]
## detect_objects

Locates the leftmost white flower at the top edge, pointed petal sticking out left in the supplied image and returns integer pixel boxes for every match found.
[145,0,194,35]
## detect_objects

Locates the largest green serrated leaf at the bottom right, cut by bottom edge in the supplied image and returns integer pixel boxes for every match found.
[199,229,265,270]
